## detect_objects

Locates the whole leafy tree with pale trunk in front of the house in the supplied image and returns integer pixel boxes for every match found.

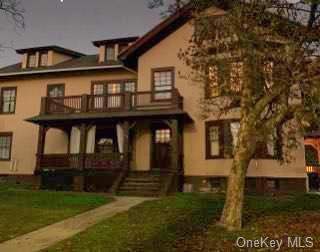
[150,0,320,229]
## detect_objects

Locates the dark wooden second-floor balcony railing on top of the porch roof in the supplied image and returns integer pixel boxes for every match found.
[41,89,183,114]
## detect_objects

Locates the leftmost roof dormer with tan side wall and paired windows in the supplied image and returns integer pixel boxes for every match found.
[16,46,84,69]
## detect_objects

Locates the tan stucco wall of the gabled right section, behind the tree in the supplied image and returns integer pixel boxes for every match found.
[138,20,306,177]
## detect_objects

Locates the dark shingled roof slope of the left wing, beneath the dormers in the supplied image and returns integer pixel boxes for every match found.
[0,55,123,75]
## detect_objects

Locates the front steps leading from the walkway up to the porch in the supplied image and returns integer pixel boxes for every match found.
[118,171,161,197]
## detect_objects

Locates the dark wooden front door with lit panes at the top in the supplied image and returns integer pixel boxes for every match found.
[152,127,171,170]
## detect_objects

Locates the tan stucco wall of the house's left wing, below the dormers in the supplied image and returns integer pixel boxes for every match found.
[0,71,136,174]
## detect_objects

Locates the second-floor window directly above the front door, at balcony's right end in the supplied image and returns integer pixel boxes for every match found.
[153,68,174,100]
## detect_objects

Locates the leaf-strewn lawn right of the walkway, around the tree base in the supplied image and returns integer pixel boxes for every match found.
[45,194,320,252]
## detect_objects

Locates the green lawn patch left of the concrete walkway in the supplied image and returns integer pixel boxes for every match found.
[0,183,112,242]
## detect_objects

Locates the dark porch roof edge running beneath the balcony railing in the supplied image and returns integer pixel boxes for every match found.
[25,109,194,125]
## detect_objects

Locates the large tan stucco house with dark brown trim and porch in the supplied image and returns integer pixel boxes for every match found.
[0,5,307,195]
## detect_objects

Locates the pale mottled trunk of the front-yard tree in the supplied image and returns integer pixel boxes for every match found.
[220,122,255,230]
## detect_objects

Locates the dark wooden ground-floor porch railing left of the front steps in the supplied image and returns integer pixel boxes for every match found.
[37,153,125,170]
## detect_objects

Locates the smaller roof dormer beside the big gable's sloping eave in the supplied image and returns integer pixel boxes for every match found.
[93,37,139,63]
